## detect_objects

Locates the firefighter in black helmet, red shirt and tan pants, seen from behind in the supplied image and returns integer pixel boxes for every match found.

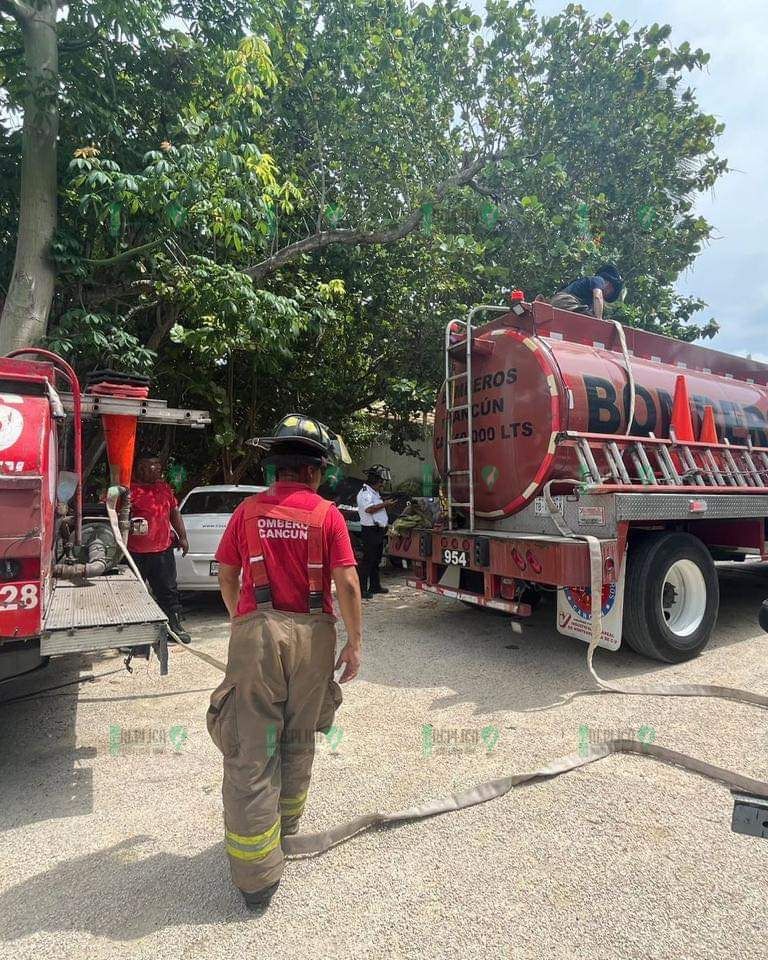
[207,414,362,909]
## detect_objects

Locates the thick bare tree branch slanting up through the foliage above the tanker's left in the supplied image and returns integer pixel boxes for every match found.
[243,153,502,280]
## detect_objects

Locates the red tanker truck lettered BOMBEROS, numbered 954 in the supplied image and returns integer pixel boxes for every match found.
[388,300,768,662]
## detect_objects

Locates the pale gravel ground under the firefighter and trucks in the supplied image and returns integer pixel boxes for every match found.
[0,567,768,960]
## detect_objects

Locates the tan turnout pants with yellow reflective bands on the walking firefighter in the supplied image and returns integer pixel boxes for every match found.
[206,610,341,893]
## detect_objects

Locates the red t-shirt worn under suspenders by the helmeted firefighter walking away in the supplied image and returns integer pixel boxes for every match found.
[216,481,356,616]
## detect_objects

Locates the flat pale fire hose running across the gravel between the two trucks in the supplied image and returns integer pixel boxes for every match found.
[107,480,768,858]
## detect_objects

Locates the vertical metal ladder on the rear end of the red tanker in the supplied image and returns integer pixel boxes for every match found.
[445,305,509,530]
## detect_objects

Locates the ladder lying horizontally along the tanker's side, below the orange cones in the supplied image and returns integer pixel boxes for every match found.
[562,430,768,493]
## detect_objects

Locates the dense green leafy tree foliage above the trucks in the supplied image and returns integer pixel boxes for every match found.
[0,0,727,478]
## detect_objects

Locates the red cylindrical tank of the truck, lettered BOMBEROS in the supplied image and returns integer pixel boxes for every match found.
[434,302,768,520]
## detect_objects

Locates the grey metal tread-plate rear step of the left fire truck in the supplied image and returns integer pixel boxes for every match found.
[40,570,167,656]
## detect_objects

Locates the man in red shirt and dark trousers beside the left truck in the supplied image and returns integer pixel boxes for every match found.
[128,454,192,643]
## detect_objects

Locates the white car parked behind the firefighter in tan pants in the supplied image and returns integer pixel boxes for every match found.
[176,484,267,590]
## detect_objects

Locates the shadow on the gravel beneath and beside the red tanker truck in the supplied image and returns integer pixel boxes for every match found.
[363,563,768,713]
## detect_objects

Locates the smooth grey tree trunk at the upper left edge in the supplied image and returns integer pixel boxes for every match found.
[0,0,59,355]
